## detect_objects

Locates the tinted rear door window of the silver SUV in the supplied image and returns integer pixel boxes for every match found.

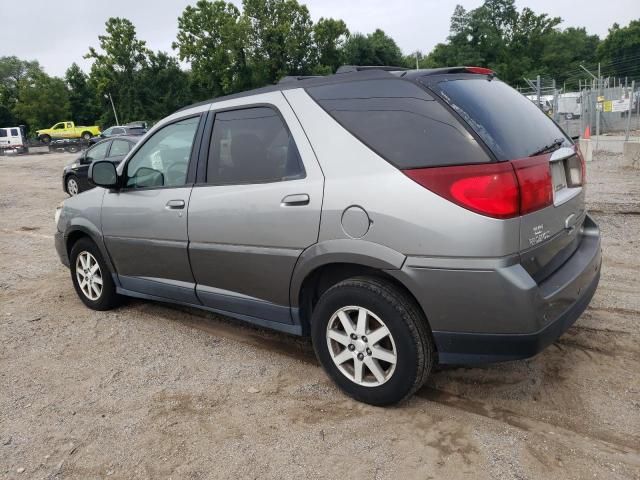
[207,107,304,184]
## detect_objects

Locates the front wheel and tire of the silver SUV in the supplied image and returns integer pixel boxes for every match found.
[69,237,122,310]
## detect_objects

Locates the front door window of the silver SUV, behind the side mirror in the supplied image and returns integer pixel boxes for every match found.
[126,117,200,188]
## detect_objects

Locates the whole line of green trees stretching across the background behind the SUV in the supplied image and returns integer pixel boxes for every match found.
[0,0,640,132]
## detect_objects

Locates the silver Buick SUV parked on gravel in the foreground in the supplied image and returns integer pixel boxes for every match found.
[56,67,601,405]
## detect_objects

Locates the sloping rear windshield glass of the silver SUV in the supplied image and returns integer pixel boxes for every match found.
[437,76,571,160]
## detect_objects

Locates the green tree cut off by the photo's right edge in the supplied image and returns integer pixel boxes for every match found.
[597,19,640,80]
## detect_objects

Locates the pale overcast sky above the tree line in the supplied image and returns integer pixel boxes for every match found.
[0,0,640,76]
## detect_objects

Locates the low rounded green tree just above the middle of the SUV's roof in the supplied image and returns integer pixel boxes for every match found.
[344,29,403,65]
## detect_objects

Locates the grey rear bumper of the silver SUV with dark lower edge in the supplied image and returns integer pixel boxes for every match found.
[389,215,602,364]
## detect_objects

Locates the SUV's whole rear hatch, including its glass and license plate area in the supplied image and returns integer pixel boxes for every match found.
[420,74,585,282]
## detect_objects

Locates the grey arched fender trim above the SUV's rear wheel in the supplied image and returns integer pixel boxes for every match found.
[289,238,406,308]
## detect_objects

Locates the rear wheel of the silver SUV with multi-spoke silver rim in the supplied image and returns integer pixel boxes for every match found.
[311,277,435,406]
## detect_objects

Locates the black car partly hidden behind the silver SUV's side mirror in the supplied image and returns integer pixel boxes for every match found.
[62,136,141,196]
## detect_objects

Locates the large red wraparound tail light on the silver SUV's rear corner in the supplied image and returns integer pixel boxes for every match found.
[404,155,553,219]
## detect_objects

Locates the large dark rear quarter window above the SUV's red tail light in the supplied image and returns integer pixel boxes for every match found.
[307,79,490,169]
